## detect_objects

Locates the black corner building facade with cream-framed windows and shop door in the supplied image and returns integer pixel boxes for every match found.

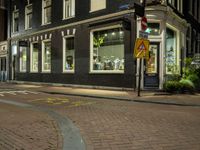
[8,0,200,89]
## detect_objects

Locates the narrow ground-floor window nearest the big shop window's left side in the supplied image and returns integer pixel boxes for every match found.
[63,37,75,72]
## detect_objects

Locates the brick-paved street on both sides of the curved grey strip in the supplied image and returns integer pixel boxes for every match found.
[0,82,200,150]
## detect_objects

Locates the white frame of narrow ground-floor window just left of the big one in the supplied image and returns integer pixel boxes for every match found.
[63,35,76,73]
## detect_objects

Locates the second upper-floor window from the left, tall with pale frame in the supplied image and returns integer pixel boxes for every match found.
[25,5,33,29]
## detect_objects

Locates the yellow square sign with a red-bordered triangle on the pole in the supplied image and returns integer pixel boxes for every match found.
[134,38,149,58]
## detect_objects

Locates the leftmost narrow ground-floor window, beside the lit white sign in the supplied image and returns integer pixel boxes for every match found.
[20,47,27,72]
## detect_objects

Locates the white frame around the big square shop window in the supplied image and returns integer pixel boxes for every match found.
[89,25,125,74]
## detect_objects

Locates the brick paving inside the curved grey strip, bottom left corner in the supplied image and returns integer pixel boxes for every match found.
[0,103,62,150]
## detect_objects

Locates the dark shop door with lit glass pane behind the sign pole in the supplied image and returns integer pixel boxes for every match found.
[144,43,160,89]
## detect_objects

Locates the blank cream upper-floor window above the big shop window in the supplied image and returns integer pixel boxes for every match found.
[90,0,106,12]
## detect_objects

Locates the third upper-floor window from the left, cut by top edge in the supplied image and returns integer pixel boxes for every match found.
[42,0,51,24]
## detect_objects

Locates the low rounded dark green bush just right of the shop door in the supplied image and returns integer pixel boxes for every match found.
[164,80,182,93]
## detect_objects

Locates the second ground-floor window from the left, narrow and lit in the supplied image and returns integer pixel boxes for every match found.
[30,43,39,72]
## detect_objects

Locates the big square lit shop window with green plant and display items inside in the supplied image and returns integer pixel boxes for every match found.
[90,27,124,73]
